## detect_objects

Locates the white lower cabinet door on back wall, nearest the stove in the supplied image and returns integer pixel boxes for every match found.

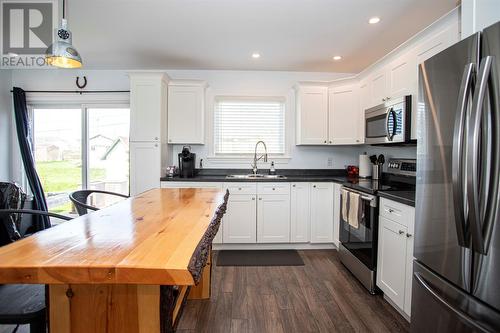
[311,183,333,243]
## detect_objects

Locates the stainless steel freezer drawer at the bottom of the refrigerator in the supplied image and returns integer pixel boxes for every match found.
[411,261,500,333]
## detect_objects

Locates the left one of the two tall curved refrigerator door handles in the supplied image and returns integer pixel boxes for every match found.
[452,63,475,247]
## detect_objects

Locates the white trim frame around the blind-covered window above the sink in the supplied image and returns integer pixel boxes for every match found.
[205,92,293,167]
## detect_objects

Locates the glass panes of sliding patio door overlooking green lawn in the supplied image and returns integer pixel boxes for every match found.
[31,105,130,215]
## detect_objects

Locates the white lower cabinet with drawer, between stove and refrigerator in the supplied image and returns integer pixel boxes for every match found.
[377,198,415,316]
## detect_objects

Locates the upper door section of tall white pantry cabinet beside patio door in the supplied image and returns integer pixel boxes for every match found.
[129,72,168,142]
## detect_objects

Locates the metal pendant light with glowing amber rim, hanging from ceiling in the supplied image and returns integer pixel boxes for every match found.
[45,0,82,68]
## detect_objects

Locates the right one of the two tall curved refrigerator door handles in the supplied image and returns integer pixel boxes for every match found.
[467,56,498,254]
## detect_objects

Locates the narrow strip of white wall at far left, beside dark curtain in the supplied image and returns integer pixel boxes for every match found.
[0,70,12,181]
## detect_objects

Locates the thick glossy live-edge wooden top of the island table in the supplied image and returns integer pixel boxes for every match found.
[0,189,227,285]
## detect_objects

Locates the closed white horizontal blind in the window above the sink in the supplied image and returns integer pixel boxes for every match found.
[214,97,286,156]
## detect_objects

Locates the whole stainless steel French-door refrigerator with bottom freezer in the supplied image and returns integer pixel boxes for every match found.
[411,23,500,333]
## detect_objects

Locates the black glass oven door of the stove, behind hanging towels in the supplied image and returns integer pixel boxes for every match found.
[340,187,378,270]
